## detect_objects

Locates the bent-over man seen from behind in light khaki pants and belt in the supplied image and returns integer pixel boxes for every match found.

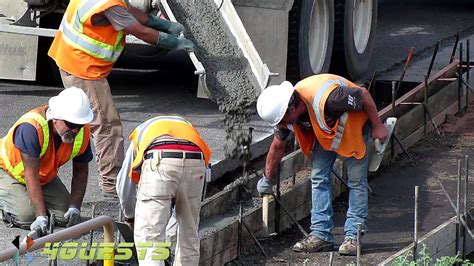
[117,116,211,265]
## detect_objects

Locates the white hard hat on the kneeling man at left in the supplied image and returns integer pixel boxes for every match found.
[47,87,94,125]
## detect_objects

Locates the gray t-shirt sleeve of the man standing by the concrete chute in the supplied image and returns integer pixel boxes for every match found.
[92,6,137,31]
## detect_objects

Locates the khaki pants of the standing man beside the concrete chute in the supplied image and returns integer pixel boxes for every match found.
[60,69,124,194]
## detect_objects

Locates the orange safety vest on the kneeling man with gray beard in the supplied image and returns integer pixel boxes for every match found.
[0,105,90,185]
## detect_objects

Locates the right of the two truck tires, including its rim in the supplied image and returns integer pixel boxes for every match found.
[331,0,377,80]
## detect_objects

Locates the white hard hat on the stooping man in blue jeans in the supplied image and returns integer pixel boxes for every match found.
[257,81,295,126]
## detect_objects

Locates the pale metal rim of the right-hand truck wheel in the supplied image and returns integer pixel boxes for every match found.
[352,0,373,54]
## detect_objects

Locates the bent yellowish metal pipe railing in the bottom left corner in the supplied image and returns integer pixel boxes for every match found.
[0,215,114,265]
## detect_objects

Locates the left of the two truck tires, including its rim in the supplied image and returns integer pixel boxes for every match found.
[287,0,334,82]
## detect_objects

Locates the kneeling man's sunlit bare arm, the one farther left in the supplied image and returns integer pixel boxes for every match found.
[20,152,46,217]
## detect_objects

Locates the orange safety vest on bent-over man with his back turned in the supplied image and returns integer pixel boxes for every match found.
[128,116,211,184]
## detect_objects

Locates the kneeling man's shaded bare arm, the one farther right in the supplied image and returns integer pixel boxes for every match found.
[69,162,89,210]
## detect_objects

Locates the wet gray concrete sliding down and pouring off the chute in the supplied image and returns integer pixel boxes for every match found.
[169,0,260,159]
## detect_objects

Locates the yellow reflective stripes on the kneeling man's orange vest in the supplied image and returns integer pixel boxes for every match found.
[2,112,49,184]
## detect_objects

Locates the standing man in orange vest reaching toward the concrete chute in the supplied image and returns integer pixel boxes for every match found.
[48,0,194,198]
